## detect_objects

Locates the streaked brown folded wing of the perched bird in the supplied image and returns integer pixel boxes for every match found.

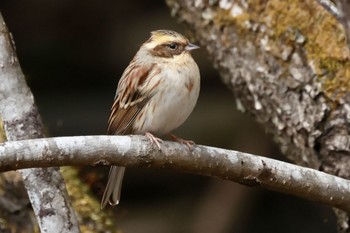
[107,60,157,135]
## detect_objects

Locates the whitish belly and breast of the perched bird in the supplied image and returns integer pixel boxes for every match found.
[133,63,200,135]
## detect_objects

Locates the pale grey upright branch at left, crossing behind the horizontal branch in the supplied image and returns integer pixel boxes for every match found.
[0,14,79,233]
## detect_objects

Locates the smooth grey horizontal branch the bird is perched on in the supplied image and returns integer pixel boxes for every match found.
[0,135,350,212]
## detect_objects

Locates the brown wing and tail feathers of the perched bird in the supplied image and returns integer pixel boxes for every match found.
[101,59,159,208]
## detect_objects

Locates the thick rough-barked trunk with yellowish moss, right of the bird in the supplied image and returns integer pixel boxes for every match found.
[167,0,350,232]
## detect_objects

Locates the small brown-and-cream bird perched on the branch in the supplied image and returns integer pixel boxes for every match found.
[101,30,200,209]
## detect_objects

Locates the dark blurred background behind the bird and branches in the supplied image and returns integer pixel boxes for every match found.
[0,0,336,233]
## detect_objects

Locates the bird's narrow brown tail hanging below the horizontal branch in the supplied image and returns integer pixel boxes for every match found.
[101,166,125,209]
